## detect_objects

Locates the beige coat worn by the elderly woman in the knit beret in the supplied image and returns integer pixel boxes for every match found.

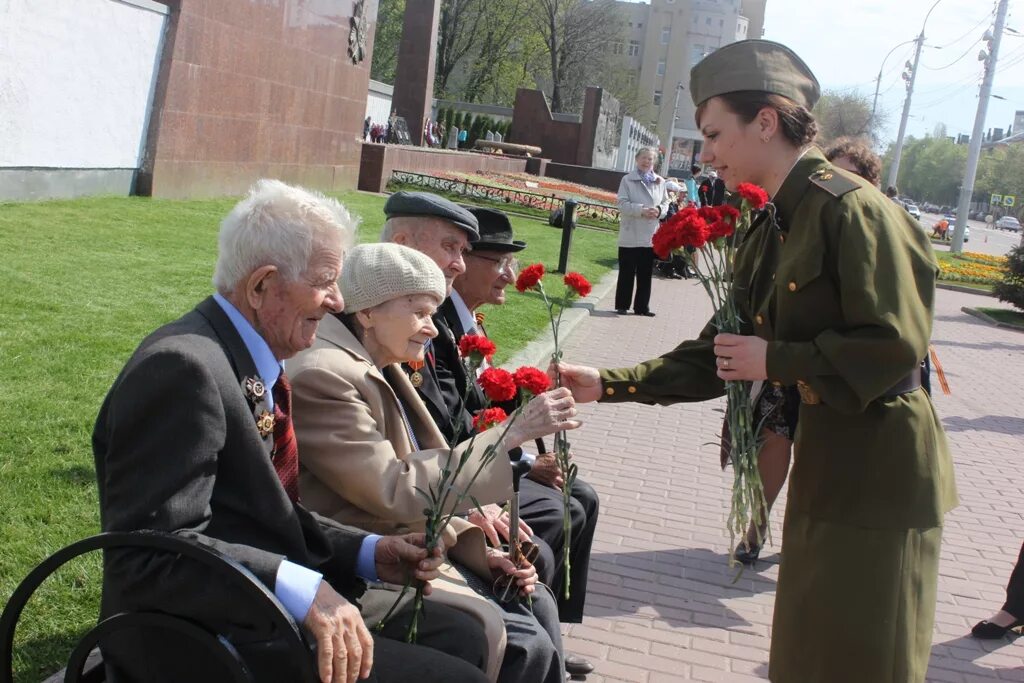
[288,315,512,680]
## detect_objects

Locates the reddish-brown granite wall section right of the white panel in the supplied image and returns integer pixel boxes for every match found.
[137,0,377,197]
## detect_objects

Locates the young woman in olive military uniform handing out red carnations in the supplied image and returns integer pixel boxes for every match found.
[562,40,956,683]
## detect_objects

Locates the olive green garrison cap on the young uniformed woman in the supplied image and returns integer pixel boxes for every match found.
[690,40,821,110]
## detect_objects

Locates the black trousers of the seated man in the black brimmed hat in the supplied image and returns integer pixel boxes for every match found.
[519,478,600,624]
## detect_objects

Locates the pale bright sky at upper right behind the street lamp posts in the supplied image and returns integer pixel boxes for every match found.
[614,0,1024,142]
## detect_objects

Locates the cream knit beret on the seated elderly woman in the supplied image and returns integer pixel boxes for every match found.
[339,242,447,313]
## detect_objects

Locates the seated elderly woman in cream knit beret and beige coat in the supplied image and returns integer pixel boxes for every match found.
[288,244,580,683]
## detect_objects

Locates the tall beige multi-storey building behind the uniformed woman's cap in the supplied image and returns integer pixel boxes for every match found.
[609,0,767,170]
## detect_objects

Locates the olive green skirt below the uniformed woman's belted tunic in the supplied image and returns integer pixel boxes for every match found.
[769,512,942,683]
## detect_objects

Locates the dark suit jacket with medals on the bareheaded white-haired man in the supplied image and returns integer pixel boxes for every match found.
[92,298,366,680]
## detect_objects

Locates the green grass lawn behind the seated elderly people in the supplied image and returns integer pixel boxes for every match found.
[0,193,615,680]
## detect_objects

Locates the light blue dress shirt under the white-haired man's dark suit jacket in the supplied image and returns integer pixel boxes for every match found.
[213,294,381,623]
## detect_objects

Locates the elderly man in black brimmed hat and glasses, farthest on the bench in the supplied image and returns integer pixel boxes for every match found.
[437,207,599,675]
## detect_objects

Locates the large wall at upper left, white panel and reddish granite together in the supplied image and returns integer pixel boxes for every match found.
[0,0,377,199]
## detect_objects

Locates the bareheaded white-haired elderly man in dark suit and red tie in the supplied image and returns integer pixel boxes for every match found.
[93,180,485,683]
